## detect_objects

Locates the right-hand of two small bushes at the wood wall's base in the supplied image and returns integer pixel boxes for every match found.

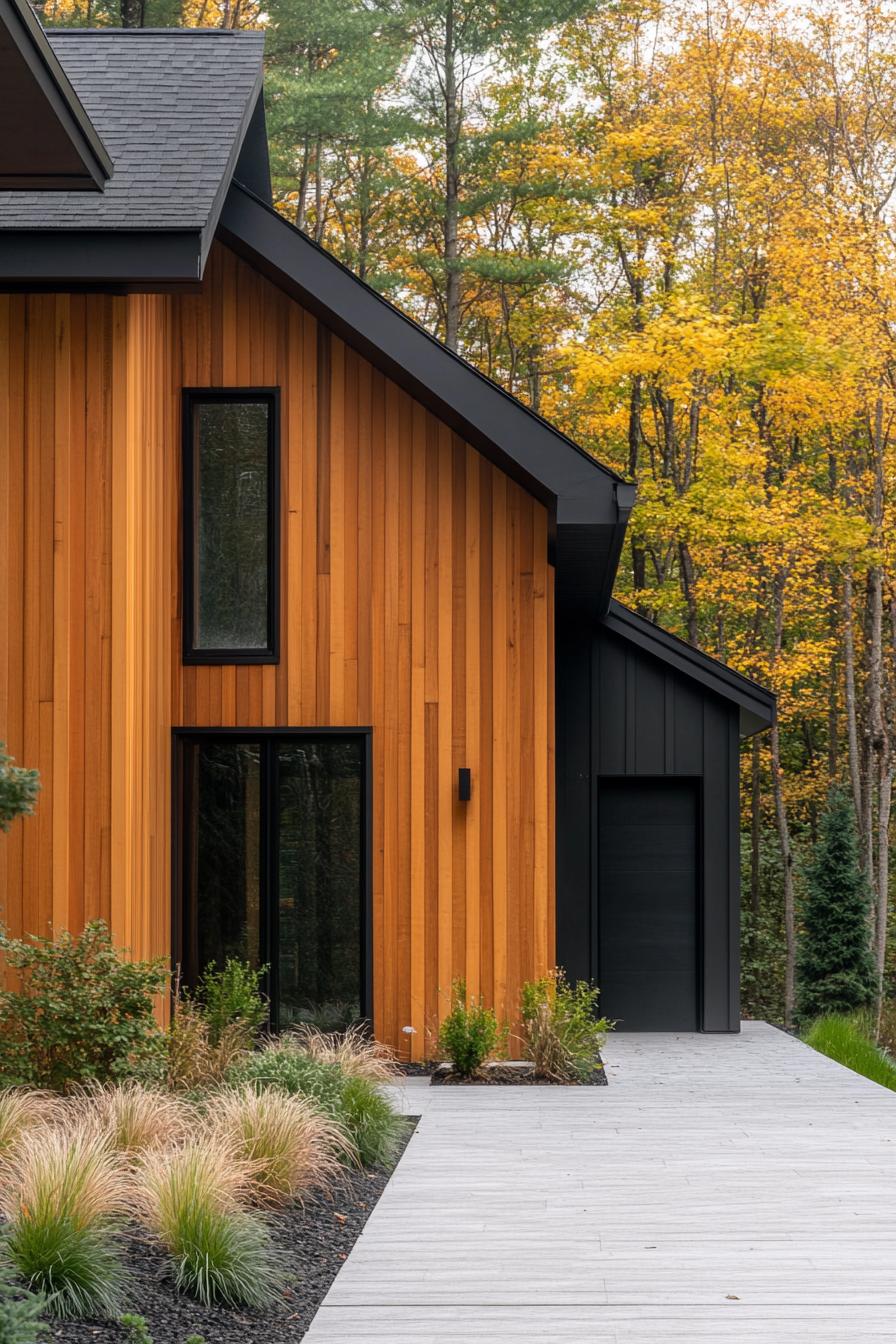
[520,970,611,1082]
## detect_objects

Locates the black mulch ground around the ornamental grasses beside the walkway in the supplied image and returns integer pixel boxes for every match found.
[47,1117,416,1344]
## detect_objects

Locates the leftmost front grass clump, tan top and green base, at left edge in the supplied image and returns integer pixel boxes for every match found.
[0,1125,129,1317]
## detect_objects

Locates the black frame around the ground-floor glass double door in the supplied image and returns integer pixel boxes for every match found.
[171,727,373,1030]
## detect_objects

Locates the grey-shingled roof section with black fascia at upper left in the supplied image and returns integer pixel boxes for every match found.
[0,28,265,282]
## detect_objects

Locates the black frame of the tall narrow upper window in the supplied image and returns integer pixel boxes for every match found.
[181,387,281,667]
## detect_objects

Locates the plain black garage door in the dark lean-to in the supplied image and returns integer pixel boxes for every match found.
[598,780,700,1031]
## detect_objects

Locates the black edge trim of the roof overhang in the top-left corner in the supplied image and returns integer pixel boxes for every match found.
[0,0,113,191]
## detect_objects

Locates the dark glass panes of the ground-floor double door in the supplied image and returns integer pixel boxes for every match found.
[176,732,368,1031]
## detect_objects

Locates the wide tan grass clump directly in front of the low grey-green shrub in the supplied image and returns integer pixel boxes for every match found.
[207,1087,347,1206]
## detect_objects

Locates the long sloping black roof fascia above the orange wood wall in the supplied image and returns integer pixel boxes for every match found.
[219,183,630,527]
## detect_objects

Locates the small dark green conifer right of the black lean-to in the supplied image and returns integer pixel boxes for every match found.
[797,788,876,1021]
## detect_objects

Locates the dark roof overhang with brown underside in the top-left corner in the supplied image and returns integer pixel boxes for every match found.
[0,0,111,192]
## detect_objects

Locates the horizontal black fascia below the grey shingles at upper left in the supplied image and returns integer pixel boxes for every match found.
[0,228,201,293]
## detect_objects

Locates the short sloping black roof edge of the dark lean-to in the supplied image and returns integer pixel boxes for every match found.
[600,601,776,738]
